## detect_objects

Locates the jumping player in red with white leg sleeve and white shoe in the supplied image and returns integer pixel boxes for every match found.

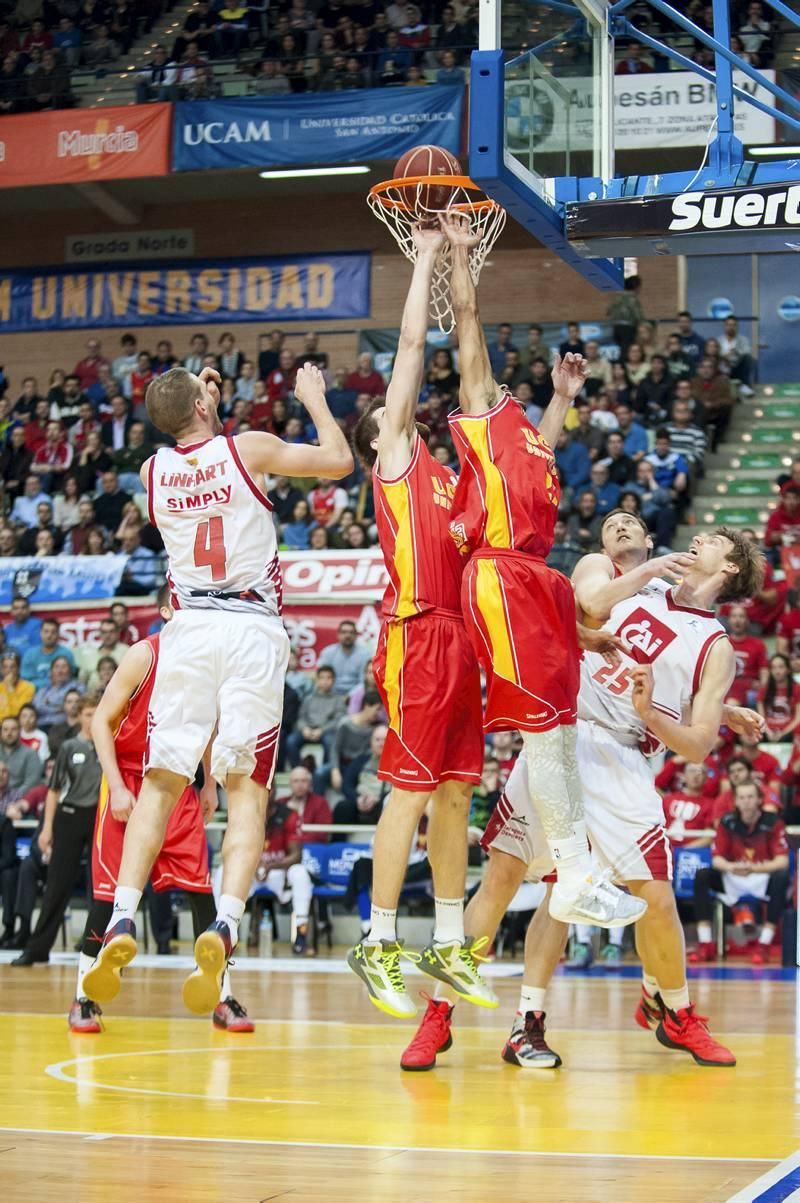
[442,213,646,935]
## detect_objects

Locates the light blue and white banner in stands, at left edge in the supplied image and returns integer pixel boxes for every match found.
[0,556,128,606]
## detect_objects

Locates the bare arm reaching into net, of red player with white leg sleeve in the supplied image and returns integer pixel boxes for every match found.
[439,212,503,414]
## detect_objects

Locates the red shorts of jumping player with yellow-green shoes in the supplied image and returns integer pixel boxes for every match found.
[373,611,484,792]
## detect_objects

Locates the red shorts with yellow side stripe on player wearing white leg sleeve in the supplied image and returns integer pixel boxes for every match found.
[461,549,580,731]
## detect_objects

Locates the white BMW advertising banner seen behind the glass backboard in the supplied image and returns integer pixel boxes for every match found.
[505,71,775,154]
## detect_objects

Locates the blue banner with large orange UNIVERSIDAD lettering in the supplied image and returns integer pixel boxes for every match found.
[0,255,369,334]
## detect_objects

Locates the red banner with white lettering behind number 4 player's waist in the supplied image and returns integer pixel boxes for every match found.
[36,602,380,670]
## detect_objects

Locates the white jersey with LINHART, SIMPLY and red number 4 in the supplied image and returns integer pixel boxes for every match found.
[148,434,282,617]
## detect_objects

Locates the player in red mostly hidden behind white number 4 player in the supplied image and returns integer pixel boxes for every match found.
[69,606,254,1033]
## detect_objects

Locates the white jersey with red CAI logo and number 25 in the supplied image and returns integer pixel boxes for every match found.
[577,581,728,753]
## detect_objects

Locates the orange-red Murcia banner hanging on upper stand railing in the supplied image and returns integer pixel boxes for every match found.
[0,105,172,188]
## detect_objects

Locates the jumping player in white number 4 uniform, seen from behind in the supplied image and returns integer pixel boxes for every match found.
[83,365,352,1014]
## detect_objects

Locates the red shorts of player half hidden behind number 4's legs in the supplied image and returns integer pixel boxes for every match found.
[91,769,212,901]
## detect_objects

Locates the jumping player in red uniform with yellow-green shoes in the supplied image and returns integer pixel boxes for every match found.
[348,226,497,1018]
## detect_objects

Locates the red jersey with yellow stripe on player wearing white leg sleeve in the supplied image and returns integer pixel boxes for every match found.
[450,393,561,558]
